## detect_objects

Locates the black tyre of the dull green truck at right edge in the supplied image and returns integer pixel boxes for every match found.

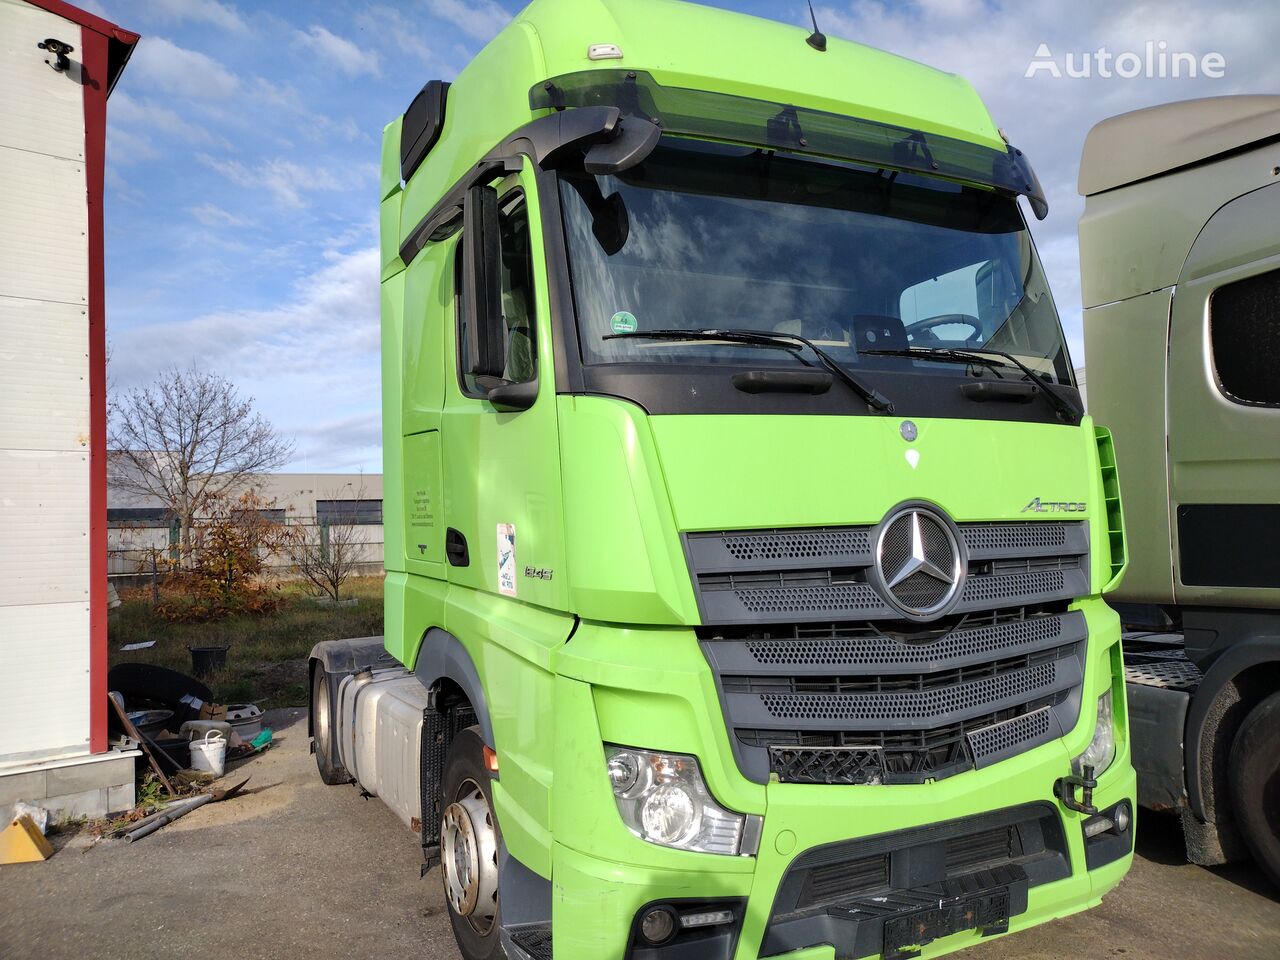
[1229,694,1280,890]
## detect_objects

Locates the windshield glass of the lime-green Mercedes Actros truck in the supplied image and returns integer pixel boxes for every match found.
[561,137,1071,392]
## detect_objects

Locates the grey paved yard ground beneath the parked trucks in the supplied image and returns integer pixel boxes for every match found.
[0,710,1280,960]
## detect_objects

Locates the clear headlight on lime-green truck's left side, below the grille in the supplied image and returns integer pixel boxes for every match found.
[604,745,760,856]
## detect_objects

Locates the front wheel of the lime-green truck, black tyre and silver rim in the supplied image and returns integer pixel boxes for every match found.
[440,727,506,960]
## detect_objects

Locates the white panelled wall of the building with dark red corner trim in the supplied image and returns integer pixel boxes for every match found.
[0,0,90,765]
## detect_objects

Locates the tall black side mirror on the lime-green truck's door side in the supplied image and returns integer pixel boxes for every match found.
[462,184,507,378]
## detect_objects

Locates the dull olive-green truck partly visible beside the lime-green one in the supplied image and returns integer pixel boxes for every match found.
[1079,96,1280,886]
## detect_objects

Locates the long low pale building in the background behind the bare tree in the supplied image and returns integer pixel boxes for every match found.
[106,474,383,586]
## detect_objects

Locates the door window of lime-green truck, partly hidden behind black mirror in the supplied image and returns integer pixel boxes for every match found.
[453,192,538,397]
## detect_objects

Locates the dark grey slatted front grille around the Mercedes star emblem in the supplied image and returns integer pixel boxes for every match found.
[686,521,1088,783]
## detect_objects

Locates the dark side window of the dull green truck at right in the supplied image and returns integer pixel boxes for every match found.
[1208,270,1280,406]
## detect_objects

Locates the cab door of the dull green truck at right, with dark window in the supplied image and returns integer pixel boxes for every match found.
[1167,184,1280,605]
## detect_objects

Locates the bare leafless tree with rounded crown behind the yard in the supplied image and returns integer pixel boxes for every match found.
[109,367,293,563]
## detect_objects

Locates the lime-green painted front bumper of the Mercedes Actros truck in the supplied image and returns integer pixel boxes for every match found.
[552,602,1135,960]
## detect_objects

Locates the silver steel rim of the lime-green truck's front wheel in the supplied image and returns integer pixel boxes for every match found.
[440,780,498,936]
